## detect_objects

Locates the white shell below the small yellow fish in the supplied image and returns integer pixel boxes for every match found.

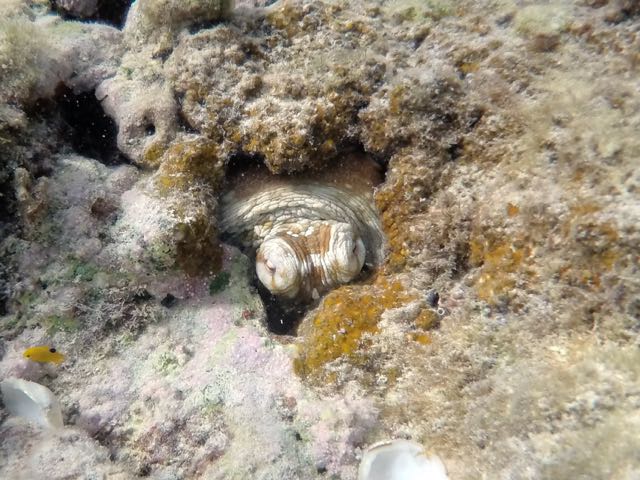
[0,378,62,428]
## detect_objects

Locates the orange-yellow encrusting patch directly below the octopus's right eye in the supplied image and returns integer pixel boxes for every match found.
[294,277,415,381]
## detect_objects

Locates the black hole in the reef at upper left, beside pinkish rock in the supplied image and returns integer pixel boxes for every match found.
[56,86,126,165]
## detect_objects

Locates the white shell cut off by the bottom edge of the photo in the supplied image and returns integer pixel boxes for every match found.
[358,440,449,480]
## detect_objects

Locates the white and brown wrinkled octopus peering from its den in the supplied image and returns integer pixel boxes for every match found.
[220,153,385,301]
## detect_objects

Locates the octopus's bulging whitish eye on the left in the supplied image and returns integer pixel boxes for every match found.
[256,237,301,298]
